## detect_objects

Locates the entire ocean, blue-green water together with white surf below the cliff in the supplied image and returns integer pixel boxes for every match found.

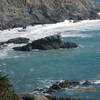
[0,20,100,100]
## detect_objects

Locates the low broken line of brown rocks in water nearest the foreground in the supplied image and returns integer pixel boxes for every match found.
[34,80,94,94]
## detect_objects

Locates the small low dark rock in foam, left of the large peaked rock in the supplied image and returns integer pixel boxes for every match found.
[6,37,29,44]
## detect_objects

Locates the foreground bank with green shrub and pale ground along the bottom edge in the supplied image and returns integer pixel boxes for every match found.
[0,73,83,100]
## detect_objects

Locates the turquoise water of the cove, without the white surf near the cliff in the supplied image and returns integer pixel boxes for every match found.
[0,21,100,100]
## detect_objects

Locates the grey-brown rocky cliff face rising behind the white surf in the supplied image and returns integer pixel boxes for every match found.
[0,0,99,29]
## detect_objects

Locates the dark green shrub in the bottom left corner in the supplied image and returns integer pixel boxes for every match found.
[0,74,18,100]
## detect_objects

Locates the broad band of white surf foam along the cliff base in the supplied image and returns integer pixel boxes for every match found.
[0,20,100,59]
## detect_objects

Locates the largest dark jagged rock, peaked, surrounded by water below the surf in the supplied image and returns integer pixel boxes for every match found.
[13,34,78,51]
